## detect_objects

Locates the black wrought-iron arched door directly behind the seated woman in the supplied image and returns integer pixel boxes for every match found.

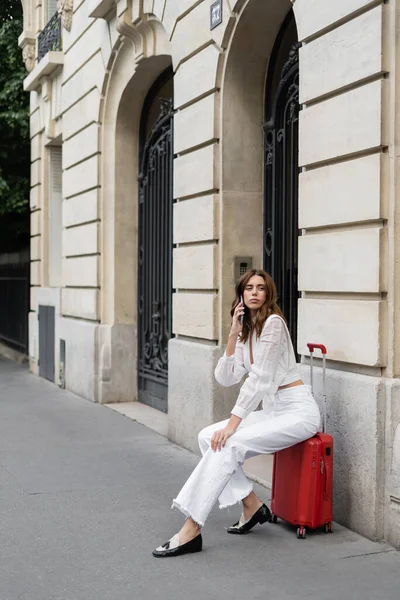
[264,10,299,348]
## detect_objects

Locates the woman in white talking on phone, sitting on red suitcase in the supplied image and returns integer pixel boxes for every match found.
[153,270,320,557]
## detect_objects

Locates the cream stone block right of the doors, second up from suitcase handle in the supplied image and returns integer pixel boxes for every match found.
[299,227,386,293]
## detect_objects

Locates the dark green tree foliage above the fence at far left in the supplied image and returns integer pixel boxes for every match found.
[0,0,30,251]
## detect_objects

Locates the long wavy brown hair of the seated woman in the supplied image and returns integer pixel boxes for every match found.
[231,269,286,342]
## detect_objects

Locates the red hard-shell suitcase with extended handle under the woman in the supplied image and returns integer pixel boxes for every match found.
[271,344,333,539]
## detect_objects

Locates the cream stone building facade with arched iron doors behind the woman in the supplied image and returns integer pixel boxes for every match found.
[20,0,400,546]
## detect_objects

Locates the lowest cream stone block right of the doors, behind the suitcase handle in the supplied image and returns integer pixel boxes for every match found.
[297,298,387,366]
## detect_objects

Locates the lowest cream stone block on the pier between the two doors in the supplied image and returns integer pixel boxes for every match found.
[172,292,217,340]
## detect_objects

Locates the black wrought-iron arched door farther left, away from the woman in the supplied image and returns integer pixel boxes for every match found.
[138,68,173,412]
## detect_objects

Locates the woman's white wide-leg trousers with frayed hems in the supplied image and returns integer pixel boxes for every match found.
[172,385,320,526]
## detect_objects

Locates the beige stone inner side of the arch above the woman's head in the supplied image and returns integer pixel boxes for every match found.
[220,0,293,341]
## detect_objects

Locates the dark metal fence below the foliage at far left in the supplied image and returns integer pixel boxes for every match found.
[0,249,30,354]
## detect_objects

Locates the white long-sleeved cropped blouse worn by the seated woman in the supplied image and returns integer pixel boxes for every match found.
[215,315,300,419]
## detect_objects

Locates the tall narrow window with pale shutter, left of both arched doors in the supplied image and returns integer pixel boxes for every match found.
[48,146,62,287]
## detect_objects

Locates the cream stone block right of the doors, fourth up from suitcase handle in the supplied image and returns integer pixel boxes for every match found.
[299,80,385,166]
